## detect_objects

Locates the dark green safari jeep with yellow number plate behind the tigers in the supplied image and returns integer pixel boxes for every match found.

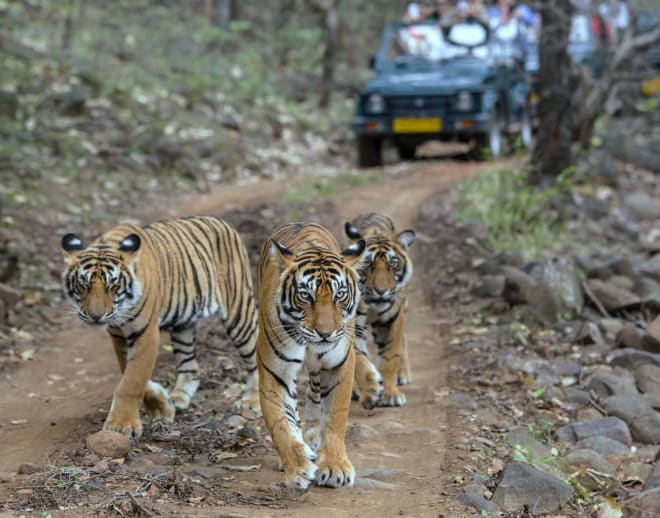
[353,21,532,167]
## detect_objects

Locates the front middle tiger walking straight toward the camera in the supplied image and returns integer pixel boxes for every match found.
[257,223,365,491]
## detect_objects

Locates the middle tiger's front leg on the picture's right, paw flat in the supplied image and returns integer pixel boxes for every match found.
[316,346,355,487]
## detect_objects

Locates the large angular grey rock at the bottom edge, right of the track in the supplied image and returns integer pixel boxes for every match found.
[492,462,573,514]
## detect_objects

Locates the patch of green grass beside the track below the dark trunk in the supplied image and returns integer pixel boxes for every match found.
[457,168,582,258]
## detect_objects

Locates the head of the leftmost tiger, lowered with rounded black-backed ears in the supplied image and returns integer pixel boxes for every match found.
[62,234,141,325]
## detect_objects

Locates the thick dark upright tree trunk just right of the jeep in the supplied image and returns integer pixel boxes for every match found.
[532,0,576,183]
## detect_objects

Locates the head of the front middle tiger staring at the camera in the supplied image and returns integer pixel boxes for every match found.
[271,240,365,346]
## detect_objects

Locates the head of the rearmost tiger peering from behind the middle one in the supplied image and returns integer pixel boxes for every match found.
[344,222,415,305]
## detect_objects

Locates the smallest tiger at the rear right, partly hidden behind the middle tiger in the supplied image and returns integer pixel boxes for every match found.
[344,212,415,408]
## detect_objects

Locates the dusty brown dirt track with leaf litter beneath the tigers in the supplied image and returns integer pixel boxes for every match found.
[0,161,510,517]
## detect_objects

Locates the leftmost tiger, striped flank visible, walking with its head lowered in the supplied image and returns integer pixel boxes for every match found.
[62,217,258,438]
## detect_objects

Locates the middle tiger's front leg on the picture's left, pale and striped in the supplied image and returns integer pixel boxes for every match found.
[257,350,316,491]
